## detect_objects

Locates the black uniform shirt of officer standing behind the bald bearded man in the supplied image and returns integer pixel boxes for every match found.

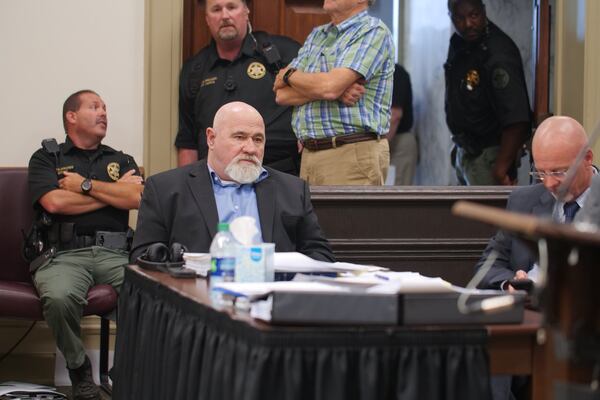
[175,32,300,174]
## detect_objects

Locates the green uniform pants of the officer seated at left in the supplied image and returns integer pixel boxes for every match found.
[33,246,128,369]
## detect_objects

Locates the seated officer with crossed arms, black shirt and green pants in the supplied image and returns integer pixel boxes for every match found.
[29,90,143,400]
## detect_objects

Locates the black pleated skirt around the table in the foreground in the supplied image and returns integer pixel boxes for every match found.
[113,269,490,400]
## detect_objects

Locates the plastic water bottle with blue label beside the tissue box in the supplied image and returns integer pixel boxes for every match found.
[210,222,237,307]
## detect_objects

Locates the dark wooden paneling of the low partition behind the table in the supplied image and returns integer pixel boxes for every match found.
[311,186,511,286]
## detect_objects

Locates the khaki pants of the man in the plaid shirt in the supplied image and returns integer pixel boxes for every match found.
[300,139,390,185]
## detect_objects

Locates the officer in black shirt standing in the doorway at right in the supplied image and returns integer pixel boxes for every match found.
[444,0,531,185]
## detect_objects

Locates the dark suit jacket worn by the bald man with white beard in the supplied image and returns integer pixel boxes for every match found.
[130,160,335,262]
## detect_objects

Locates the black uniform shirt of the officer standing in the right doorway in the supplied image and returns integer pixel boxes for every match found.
[444,21,531,155]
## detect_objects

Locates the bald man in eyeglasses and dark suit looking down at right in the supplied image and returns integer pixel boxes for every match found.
[476,116,596,291]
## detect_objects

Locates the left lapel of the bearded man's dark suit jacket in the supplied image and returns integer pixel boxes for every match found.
[187,160,219,237]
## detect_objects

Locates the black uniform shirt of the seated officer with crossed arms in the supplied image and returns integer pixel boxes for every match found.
[29,136,139,235]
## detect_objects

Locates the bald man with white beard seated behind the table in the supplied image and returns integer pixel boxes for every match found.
[130,102,334,262]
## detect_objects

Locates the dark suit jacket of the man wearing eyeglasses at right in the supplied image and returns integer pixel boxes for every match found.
[475,183,555,289]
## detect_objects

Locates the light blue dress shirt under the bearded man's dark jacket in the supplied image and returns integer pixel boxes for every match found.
[208,166,269,243]
